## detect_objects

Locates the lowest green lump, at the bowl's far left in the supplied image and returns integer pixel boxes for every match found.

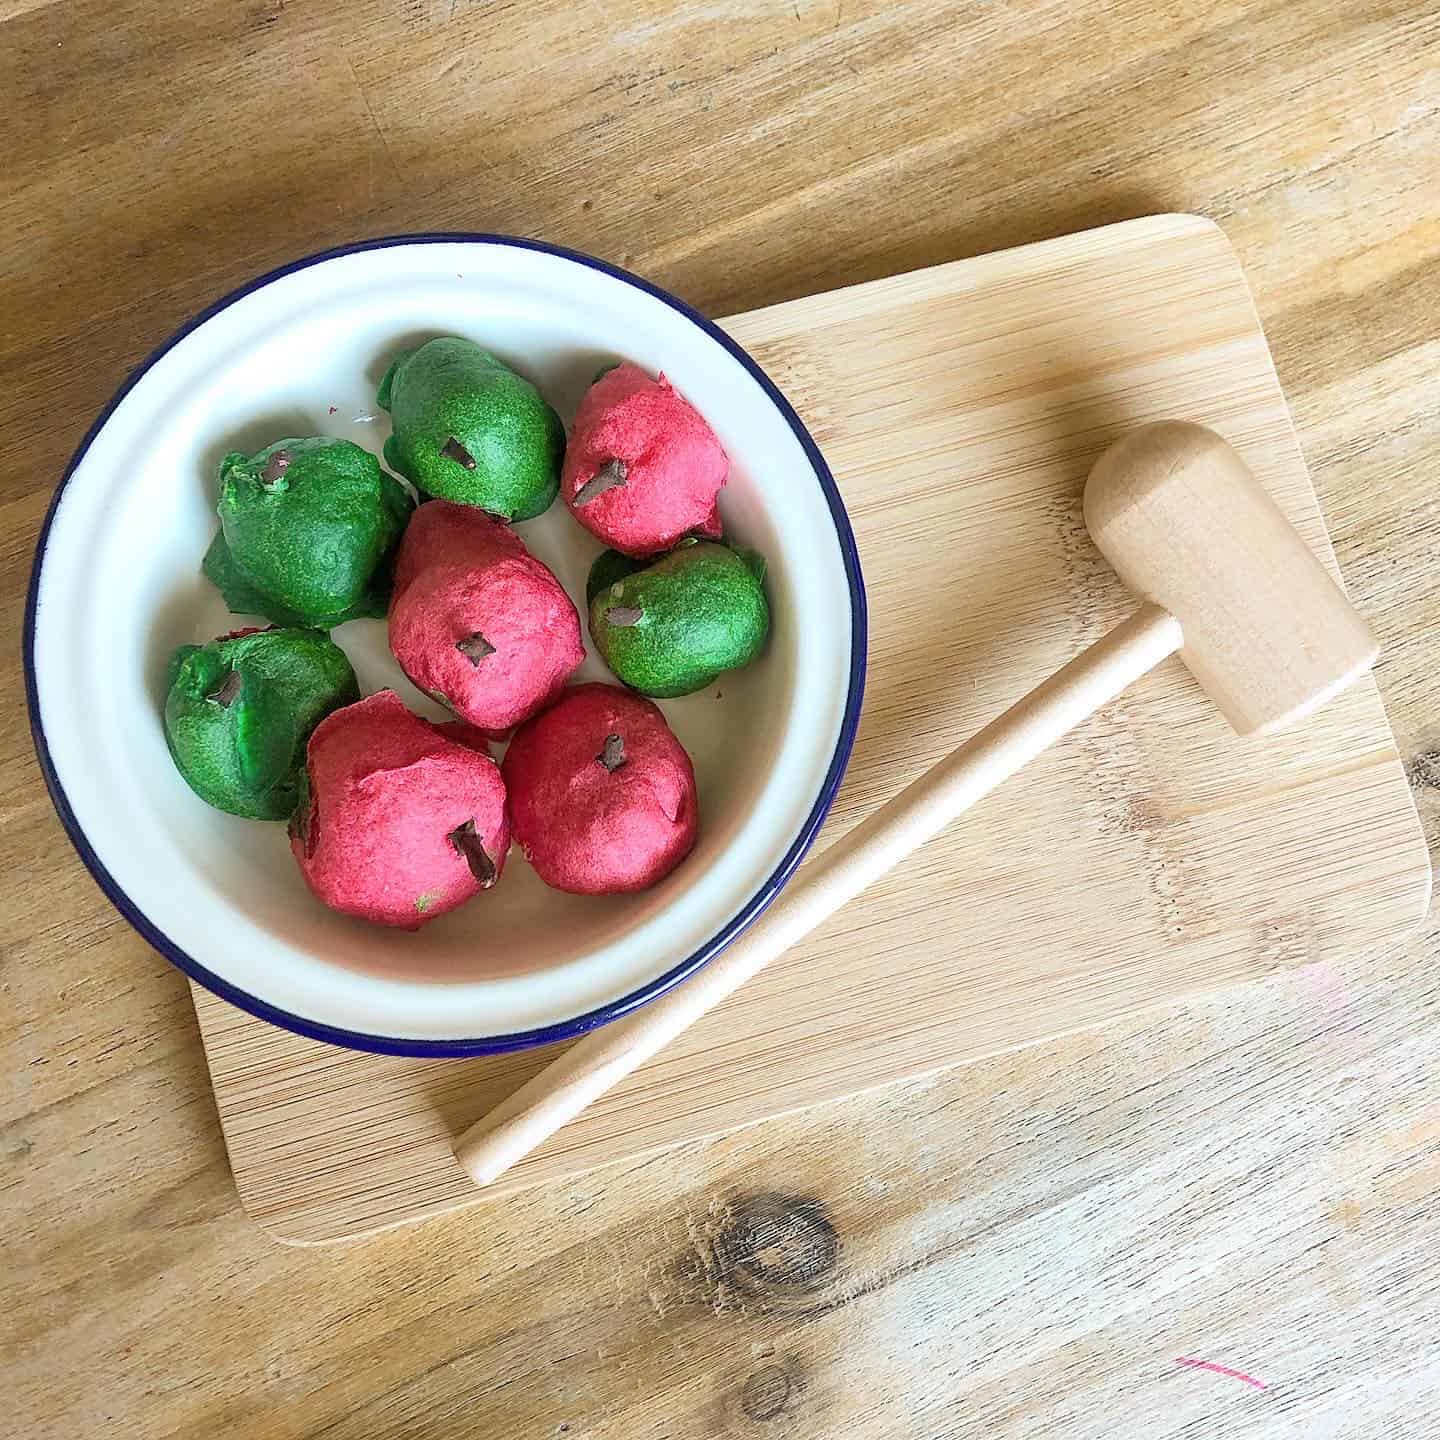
[166,629,360,819]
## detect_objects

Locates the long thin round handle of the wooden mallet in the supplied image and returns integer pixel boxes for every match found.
[455,605,1182,1185]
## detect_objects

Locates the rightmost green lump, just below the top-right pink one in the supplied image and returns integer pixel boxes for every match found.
[588,541,770,700]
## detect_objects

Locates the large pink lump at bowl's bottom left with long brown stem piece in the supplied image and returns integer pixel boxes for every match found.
[291,690,510,930]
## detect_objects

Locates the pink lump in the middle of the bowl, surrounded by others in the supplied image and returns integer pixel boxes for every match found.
[390,500,585,734]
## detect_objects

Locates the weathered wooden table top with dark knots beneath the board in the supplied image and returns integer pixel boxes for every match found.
[0,0,1440,1440]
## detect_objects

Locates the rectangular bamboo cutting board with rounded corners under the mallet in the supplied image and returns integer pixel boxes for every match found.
[194,216,1430,1244]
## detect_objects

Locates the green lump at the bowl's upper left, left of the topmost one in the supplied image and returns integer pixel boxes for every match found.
[203,436,412,629]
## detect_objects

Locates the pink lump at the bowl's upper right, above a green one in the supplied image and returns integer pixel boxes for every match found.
[560,364,730,556]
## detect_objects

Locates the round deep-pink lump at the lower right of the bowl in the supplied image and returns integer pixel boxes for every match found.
[503,684,698,894]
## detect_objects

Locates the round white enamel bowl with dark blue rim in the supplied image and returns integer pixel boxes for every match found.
[33,240,858,1043]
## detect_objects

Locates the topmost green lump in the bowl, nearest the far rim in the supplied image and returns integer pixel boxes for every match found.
[376,337,564,520]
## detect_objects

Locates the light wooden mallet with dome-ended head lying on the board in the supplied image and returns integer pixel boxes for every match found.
[455,422,1377,1185]
